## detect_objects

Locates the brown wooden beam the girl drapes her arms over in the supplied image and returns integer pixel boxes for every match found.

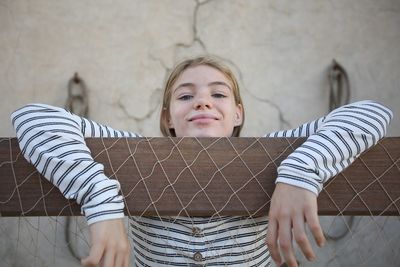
[0,137,400,216]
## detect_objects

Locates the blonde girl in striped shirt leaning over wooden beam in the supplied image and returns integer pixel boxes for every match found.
[12,56,392,266]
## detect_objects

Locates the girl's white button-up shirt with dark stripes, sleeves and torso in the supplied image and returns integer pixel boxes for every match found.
[12,101,393,266]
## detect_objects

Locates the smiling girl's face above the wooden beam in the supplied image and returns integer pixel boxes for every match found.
[168,65,243,137]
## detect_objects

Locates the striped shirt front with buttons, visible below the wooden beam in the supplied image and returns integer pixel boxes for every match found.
[130,217,270,266]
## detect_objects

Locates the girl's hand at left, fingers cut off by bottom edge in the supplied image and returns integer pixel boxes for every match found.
[81,219,130,267]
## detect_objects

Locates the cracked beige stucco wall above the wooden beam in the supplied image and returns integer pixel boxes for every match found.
[0,0,400,266]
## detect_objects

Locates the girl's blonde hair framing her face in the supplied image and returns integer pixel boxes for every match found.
[160,55,244,137]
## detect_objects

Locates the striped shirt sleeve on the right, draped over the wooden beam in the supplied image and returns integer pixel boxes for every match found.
[266,100,393,195]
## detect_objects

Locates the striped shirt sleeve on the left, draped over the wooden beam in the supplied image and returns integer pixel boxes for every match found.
[11,104,138,224]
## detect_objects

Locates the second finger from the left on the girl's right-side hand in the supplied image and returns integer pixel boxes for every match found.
[278,219,297,267]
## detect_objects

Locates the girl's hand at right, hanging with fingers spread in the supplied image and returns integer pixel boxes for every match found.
[267,183,325,267]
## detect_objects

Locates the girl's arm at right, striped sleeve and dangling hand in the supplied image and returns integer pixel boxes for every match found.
[267,101,393,266]
